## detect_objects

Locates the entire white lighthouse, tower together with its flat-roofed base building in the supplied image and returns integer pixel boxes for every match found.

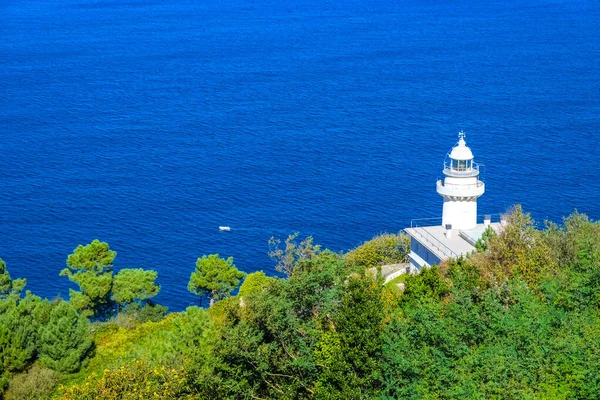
[405,132,500,272]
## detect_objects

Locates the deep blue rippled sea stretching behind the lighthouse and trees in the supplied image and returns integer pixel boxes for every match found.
[0,0,600,311]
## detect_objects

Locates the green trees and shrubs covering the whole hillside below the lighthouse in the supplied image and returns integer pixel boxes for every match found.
[0,207,600,400]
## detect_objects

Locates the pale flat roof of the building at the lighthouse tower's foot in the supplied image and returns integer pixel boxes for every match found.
[404,222,500,260]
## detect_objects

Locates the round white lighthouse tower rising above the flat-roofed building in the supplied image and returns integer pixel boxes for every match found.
[437,131,485,230]
